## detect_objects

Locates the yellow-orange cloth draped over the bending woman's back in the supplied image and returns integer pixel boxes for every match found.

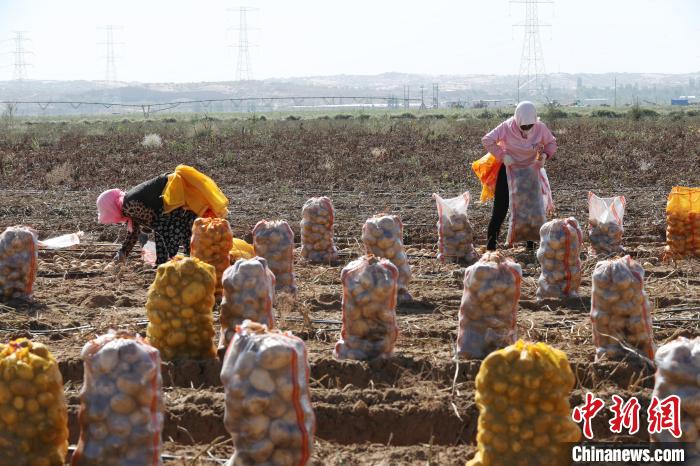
[163,165,228,218]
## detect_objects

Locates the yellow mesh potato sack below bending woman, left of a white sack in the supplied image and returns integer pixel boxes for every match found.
[146,257,216,361]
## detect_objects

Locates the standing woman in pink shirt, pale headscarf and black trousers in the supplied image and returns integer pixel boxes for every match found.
[481,101,557,251]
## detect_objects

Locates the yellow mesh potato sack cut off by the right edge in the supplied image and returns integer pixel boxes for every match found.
[666,186,700,259]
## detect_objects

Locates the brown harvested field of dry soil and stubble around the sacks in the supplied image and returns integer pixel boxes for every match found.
[0,115,700,465]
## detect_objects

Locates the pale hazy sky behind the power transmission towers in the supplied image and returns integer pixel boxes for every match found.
[0,0,700,82]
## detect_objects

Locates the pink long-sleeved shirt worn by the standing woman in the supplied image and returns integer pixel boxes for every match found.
[481,117,557,167]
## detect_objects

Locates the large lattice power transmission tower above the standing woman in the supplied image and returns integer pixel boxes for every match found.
[511,0,553,99]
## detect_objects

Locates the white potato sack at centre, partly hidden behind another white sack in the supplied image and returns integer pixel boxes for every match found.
[362,214,411,301]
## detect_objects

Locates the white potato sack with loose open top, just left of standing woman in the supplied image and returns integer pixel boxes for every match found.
[433,192,479,264]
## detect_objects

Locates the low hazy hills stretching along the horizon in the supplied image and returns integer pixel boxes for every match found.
[0,72,700,114]
